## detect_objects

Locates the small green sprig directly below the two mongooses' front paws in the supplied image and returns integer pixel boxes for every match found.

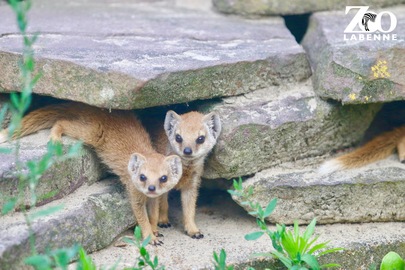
[124,226,165,270]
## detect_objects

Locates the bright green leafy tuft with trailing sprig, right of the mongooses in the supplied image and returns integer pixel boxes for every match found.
[228,179,343,270]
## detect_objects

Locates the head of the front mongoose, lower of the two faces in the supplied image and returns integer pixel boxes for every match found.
[128,153,183,198]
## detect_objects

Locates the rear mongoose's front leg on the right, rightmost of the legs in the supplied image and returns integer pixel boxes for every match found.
[181,181,204,239]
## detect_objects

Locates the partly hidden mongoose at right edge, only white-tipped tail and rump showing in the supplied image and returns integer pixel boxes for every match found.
[319,126,405,174]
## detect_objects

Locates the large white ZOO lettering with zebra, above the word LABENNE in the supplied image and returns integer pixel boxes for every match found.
[344,6,397,33]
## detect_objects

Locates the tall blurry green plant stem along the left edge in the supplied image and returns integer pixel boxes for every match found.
[0,0,84,269]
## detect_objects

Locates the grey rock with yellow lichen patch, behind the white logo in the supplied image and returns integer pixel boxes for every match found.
[302,6,405,104]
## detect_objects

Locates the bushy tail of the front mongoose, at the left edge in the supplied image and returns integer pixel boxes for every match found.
[0,104,68,143]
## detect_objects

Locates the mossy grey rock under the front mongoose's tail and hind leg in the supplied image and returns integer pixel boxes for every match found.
[0,131,103,209]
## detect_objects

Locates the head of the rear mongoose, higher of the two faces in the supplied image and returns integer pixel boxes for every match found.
[164,111,221,160]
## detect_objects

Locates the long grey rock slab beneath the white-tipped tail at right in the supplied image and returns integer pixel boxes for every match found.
[230,156,405,224]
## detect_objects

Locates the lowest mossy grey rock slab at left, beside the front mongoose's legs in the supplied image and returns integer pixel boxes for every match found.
[0,180,135,270]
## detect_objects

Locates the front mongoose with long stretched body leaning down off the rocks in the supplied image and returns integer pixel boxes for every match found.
[0,103,182,245]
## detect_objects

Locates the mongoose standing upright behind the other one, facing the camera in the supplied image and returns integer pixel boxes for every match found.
[152,111,221,239]
